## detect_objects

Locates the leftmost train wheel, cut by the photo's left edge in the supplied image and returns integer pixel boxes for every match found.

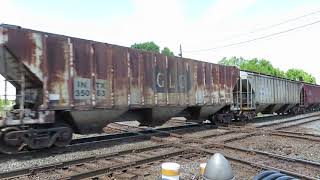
[0,127,23,154]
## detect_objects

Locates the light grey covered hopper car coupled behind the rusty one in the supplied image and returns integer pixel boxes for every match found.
[232,71,302,119]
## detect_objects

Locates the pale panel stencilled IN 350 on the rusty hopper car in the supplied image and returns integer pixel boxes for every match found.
[73,78,91,100]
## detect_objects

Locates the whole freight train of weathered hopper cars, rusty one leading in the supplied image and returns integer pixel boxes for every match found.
[0,24,320,153]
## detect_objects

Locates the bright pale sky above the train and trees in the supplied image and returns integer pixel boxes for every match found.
[0,0,320,95]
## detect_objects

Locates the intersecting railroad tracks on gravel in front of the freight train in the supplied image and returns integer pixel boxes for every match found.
[0,114,320,179]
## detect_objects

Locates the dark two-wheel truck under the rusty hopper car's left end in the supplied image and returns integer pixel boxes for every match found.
[0,123,73,154]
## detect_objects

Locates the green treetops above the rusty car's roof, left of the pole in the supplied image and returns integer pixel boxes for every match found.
[131,41,174,56]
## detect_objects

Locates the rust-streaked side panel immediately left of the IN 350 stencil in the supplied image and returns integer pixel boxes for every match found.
[46,35,72,108]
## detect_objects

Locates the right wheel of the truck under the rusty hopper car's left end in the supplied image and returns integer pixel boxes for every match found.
[54,123,73,147]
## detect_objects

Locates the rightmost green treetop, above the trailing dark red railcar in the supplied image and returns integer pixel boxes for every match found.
[286,69,316,84]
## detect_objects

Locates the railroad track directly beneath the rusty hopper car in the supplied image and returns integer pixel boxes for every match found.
[0,124,217,162]
